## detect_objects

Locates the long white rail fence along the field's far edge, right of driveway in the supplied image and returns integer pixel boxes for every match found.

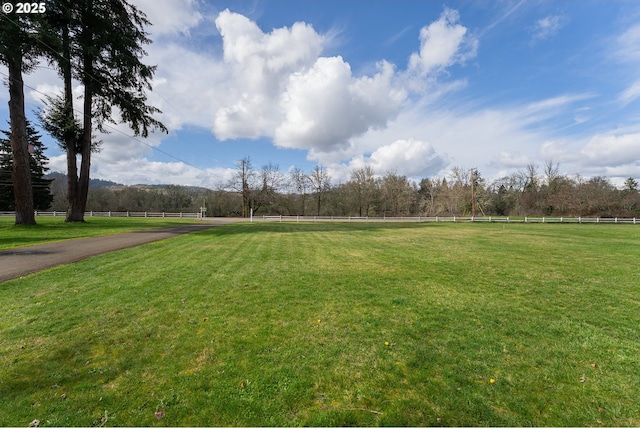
[251,215,640,224]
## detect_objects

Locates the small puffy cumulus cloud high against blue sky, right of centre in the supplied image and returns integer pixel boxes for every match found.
[409,8,478,76]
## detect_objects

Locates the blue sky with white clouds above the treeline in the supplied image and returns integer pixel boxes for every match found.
[0,0,640,189]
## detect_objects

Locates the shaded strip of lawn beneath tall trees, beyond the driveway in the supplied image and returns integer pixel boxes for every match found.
[0,217,194,250]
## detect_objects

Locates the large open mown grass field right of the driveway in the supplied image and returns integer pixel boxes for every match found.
[0,223,640,426]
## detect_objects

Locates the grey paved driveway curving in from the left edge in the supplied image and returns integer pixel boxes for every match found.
[0,221,241,283]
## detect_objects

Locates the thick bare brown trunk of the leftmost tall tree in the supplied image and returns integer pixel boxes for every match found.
[7,55,36,224]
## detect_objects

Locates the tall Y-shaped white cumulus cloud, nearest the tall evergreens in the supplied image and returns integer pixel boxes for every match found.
[213,10,323,140]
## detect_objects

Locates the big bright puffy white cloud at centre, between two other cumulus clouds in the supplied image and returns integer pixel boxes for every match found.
[274,57,406,156]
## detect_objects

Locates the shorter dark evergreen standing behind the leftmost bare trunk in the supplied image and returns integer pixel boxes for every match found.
[0,121,53,211]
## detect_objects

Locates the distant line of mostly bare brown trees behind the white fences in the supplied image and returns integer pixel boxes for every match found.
[52,158,640,217]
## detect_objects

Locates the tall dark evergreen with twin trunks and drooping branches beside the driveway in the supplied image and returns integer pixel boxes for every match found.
[42,0,167,222]
